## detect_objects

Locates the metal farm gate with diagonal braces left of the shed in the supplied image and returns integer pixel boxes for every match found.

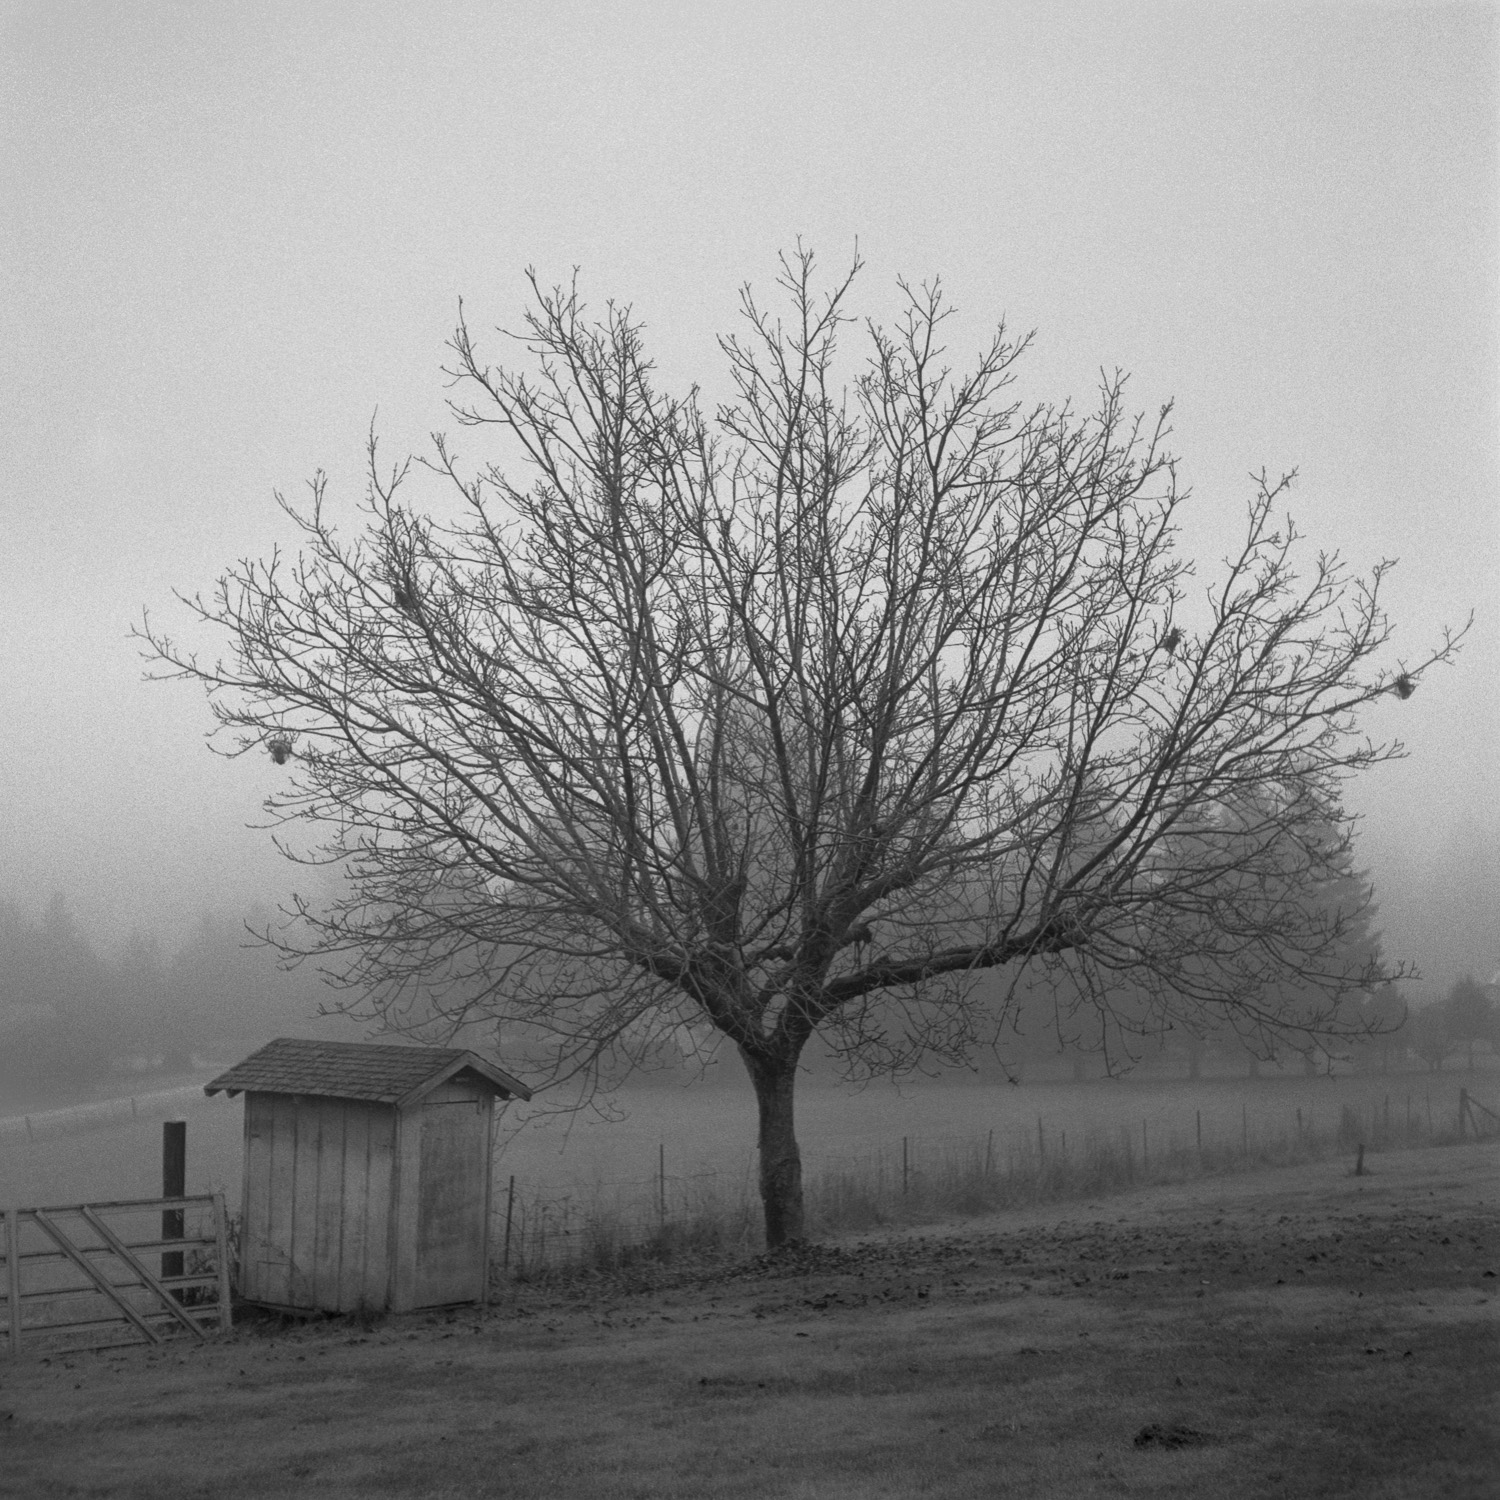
[0,1193,230,1355]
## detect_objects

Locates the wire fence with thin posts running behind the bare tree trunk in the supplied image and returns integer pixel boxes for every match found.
[491,1089,1500,1283]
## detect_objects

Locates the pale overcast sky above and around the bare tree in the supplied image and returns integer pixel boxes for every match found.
[0,0,1500,984]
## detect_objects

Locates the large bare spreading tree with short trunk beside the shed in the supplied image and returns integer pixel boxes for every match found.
[143,249,1454,1247]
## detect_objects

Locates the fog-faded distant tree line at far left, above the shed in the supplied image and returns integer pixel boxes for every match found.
[0,894,347,1088]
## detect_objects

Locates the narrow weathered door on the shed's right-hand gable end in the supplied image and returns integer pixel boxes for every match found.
[414,1098,489,1307]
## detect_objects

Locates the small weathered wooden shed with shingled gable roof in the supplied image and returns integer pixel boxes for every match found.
[204,1037,531,1313]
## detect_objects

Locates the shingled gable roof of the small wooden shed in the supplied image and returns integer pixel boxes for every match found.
[203,1037,531,1104]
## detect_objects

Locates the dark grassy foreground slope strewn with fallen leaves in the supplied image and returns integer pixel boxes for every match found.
[0,1145,1500,1500]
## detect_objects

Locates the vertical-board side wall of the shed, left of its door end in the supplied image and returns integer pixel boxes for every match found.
[240,1094,396,1313]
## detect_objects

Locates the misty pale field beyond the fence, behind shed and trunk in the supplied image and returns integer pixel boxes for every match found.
[0,1059,1500,1268]
